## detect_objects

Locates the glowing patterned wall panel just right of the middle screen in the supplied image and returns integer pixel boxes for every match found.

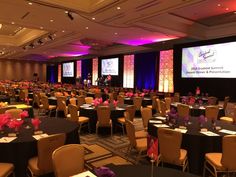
[123,55,134,88]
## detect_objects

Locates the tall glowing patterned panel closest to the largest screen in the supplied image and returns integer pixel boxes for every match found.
[158,50,174,92]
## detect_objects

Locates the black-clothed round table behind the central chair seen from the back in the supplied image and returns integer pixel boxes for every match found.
[80,104,128,133]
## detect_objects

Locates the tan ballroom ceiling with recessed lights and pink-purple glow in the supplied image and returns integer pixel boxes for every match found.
[0,0,236,61]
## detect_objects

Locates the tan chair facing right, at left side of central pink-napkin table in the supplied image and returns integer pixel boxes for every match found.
[67,104,90,132]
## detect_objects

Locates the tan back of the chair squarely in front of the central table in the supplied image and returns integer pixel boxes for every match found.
[97,106,111,126]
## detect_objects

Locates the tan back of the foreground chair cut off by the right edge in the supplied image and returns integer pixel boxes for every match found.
[221,135,236,171]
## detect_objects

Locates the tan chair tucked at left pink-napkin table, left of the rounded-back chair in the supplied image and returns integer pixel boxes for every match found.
[28,134,66,177]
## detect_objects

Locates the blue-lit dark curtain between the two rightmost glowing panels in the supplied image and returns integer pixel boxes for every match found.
[134,52,158,89]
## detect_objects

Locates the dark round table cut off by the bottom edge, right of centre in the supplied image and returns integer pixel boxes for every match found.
[108,165,198,177]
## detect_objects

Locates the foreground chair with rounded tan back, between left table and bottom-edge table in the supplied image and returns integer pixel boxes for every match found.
[52,144,85,177]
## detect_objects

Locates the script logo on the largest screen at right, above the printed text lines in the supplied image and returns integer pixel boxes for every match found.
[197,49,216,63]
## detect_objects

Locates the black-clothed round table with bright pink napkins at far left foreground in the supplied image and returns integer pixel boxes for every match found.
[0,118,80,177]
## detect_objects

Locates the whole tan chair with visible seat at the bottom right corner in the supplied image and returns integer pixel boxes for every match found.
[203,135,236,177]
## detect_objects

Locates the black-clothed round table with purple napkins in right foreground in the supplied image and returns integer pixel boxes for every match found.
[148,117,236,174]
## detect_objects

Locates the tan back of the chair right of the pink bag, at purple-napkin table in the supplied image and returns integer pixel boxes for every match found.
[158,128,182,164]
